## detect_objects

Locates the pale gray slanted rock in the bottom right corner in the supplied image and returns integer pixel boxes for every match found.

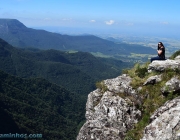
[141,97,180,140]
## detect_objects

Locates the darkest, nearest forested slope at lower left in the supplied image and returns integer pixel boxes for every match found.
[0,71,84,140]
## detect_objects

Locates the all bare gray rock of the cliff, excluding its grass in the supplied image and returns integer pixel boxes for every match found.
[77,56,180,140]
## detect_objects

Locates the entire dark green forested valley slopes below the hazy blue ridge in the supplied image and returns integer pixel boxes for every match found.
[0,39,132,140]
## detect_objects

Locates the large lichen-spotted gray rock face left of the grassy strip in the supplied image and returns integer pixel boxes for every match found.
[77,75,141,140]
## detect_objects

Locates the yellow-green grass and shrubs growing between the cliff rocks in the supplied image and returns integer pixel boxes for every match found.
[124,52,180,140]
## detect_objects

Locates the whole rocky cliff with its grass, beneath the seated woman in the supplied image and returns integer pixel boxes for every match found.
[77,54,180,140]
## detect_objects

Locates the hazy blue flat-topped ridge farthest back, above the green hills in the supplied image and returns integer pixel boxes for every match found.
[0,19,154,55]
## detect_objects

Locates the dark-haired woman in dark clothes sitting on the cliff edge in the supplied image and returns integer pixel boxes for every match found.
[151,42,165,62]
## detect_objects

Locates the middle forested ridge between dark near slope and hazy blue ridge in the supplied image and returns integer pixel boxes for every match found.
[0,39,130,95]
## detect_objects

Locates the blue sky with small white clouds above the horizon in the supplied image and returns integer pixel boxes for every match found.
[0,0,180,35]
